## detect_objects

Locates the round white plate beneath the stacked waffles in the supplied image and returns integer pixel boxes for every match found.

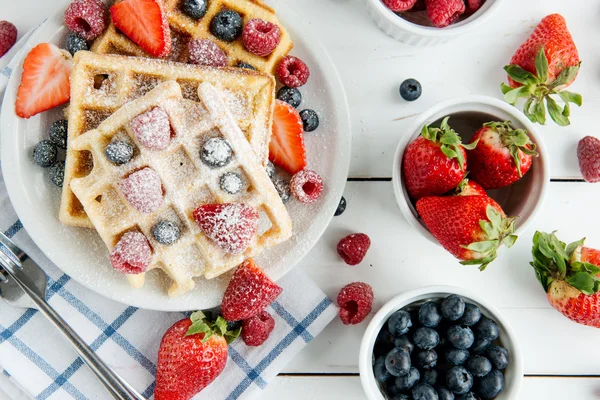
[0,3,351,311]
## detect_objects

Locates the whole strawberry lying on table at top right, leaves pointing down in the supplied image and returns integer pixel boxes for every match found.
[501,14,582,126]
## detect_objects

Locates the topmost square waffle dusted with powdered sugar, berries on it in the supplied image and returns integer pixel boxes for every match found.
[71,81,292,296]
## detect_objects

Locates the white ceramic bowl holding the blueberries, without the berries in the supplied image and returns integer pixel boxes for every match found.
[358,286,523,400]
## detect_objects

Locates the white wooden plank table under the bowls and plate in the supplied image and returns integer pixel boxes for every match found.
[0,0,600,400]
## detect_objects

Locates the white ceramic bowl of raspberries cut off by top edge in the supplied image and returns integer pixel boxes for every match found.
[365,0,502,46]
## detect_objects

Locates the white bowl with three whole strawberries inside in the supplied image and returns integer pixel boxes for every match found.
[393,96,550,270]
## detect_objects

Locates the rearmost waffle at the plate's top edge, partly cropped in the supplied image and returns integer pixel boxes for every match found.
[91,0,294,74]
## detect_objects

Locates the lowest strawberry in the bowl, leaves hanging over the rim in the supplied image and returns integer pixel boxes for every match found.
[417,196,517,271]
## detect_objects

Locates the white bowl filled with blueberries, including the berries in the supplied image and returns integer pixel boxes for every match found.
[359,286,523,400]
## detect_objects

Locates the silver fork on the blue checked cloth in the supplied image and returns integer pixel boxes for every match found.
[0,228,145,400]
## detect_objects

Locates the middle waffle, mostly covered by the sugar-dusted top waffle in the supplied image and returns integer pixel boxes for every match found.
[59,51,275,228]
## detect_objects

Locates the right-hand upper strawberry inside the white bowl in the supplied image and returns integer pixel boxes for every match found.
[467,121,538,189]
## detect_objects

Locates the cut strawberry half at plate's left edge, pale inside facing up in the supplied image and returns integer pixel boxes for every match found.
[15,43,73,118]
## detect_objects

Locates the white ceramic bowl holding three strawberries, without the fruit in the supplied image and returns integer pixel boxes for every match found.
[392,96,550,244]
